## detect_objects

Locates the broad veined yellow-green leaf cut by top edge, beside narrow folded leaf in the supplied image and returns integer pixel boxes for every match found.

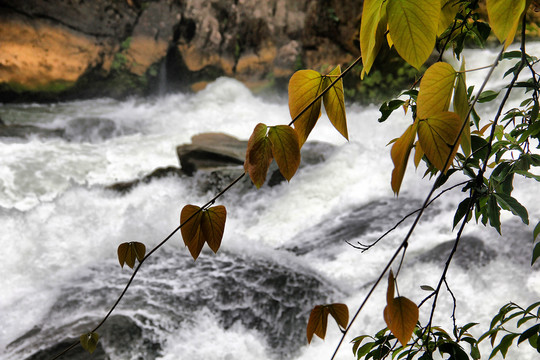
[386,0,441,69]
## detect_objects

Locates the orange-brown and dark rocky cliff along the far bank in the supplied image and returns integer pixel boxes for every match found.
[0,0,362,102]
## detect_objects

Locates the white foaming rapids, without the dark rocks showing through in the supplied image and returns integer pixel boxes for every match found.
[0,44,540,360]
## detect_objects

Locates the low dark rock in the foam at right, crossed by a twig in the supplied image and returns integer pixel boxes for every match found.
[420,236,497,269]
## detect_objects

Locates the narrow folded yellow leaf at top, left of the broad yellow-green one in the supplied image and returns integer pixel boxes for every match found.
[358,0,387,76]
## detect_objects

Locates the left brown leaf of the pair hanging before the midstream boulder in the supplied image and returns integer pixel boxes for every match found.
[244,123,272,189]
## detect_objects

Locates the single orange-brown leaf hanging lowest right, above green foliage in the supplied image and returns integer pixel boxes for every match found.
[383,296,418,346]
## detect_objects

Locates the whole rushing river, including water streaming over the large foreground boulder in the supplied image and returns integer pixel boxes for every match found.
[0,44,540,360]
